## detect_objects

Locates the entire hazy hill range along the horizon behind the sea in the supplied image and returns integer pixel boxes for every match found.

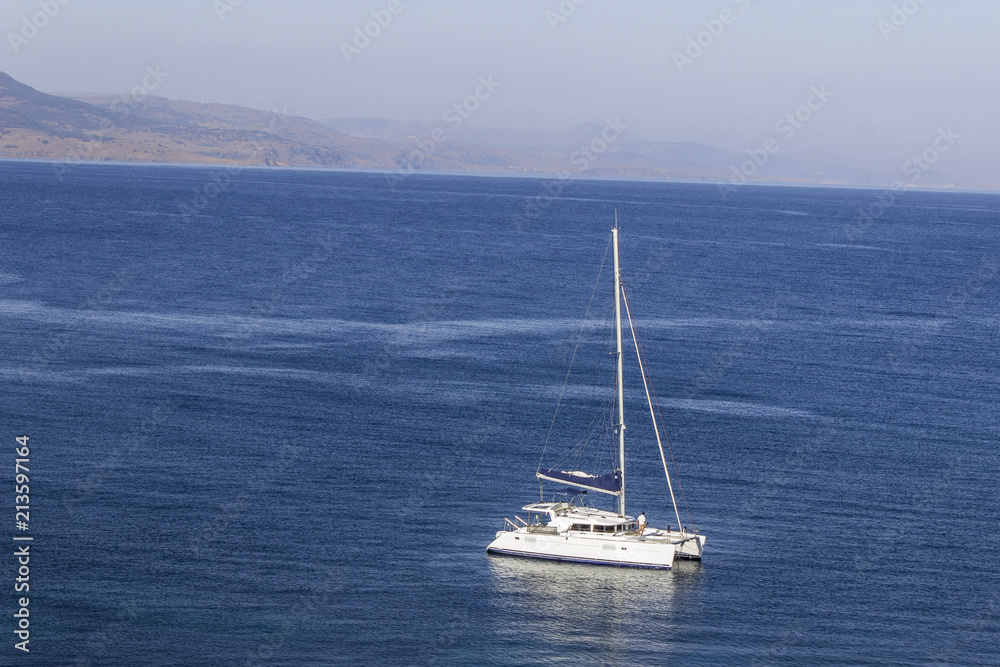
[0,73,1000,190]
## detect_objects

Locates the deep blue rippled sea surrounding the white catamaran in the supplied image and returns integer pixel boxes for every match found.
[0,161,1000,665]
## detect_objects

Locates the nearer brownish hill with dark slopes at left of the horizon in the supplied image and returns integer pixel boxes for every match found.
[0,73,404,166]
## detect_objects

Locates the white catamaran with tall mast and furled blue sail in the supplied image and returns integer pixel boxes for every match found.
[486,223,705,570]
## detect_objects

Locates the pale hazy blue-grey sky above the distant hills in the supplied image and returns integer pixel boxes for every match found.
[0,0,1000,161]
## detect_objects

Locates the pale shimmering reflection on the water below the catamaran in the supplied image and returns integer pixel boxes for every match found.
[487,556,703,663]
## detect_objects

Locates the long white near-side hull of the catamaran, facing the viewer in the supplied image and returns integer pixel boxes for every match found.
[486,530,675,570]
